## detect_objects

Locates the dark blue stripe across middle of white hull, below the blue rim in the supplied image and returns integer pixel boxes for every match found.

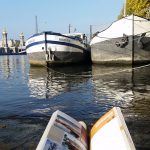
[26,40,85,50]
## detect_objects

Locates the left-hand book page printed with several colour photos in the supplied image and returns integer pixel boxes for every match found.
[37,111,87,150]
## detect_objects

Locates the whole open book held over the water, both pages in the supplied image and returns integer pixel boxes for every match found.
[36,107,135,150]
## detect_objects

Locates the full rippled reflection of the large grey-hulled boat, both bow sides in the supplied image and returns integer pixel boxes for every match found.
[92,66,150,117]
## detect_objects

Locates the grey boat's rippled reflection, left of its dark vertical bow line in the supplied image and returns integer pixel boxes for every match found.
[92,65,133,105]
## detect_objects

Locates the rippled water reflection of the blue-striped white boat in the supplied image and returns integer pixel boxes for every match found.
[29,65,91,99]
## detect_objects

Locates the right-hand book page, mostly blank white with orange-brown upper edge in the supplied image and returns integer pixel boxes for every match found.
[90,107,135,150]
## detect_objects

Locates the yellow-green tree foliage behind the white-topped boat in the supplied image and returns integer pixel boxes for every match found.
[118,0,150,19]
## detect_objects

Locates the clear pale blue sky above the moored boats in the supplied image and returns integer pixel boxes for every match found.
[0,0,124,39]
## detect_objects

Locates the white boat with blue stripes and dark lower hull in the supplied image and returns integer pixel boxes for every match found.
[26,31,89,65]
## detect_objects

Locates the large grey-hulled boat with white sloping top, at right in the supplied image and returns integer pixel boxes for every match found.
[90,15,150,64]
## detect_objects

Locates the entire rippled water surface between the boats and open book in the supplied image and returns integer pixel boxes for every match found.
[0,56,150,150]
